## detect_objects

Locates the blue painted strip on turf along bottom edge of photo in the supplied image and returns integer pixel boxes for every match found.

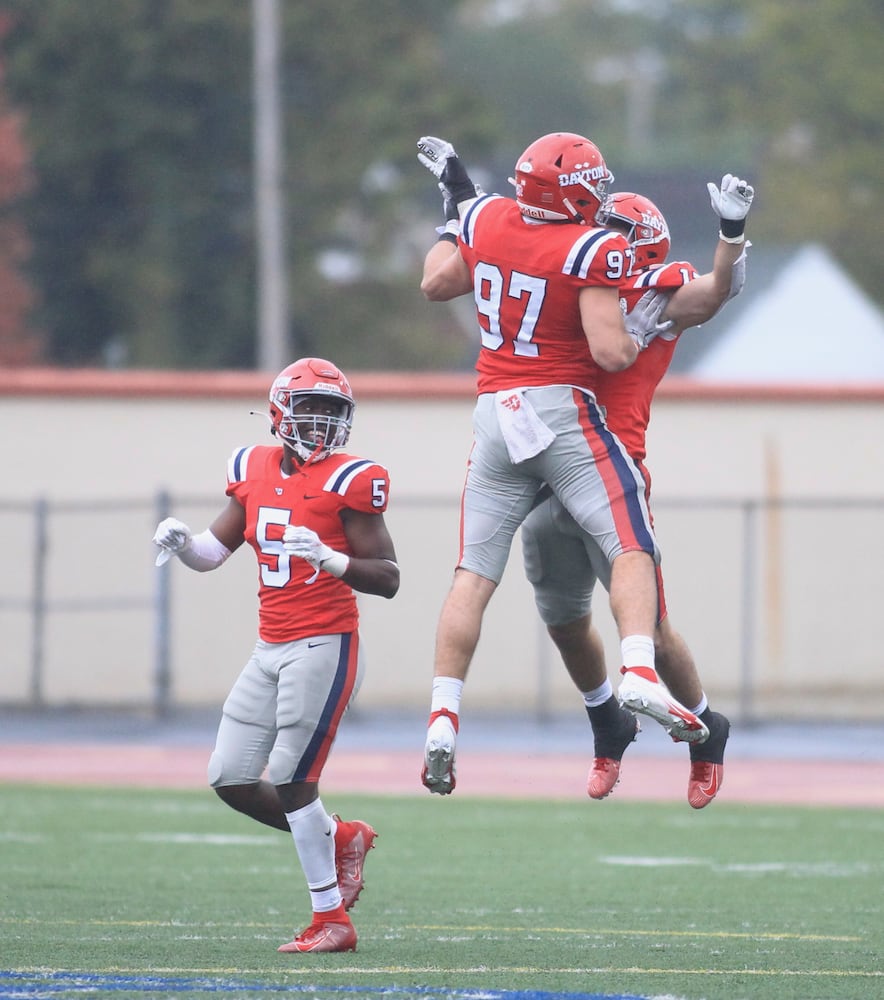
[0,970,648,1000]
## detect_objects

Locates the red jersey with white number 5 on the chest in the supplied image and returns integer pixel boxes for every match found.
[227,445,390,642]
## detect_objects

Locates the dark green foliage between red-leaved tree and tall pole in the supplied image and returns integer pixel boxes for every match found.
[8,0,254,366]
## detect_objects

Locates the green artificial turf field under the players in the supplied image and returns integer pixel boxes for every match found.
[0,785,884,1000]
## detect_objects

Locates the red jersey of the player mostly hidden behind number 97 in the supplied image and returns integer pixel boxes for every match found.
[590,260,698,470]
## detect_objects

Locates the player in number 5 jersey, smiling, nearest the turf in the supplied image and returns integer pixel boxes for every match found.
[153,358,399,952]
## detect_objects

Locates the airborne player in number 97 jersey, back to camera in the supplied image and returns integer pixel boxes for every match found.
[418,132,708,795]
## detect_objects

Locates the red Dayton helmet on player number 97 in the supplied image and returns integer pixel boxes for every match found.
[510,132,614,225]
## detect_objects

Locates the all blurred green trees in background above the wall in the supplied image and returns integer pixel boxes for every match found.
[2,0,884,368]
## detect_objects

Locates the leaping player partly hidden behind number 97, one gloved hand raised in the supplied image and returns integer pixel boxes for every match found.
[522,174,754,809]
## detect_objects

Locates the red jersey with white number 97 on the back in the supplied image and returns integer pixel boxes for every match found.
[459,195,632,393]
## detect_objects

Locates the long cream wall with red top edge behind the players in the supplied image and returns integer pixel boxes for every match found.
[0,371,884,719]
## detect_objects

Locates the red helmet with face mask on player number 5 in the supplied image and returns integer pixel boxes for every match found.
[270,358,356,462]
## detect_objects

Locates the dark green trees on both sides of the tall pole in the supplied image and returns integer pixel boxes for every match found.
[0,0,494,367]
